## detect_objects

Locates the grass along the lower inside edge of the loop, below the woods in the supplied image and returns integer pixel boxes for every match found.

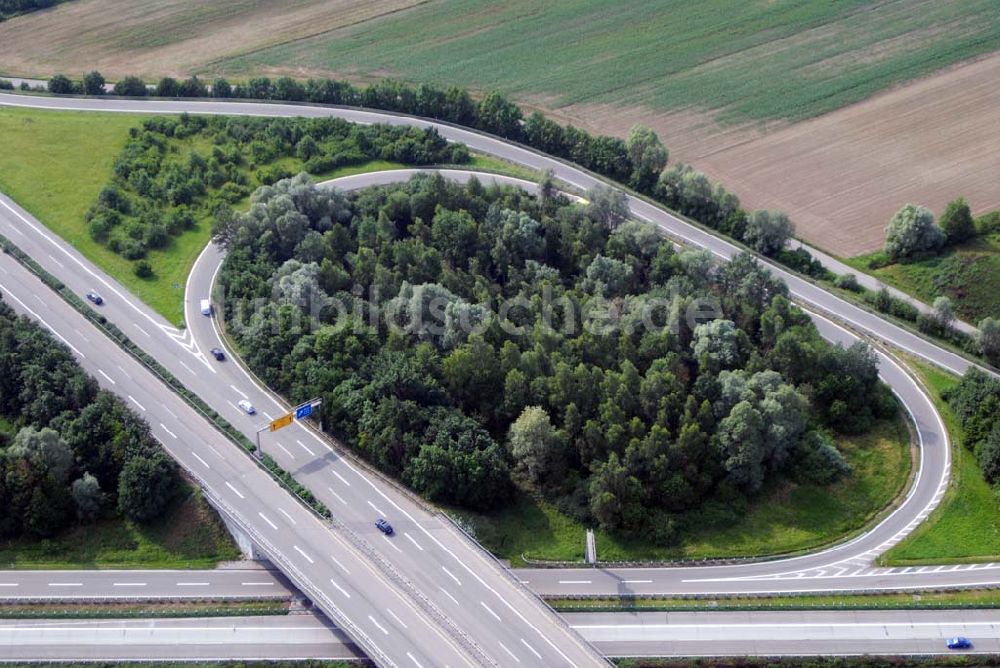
[454,418,911,566]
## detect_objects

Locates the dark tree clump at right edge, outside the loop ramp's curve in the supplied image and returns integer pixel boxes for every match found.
[945,369,1000,484]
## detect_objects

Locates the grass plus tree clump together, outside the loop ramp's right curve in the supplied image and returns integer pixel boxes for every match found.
[880,361,1000,566]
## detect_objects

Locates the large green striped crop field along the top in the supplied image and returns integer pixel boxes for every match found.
[221,0,1000,121]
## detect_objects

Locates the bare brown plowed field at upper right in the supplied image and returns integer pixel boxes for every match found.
[693,54,1000,256]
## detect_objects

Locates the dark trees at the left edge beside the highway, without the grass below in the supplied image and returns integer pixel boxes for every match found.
[0,303,179,538]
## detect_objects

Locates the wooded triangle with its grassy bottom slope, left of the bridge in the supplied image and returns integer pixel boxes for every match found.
[0,302,238,567]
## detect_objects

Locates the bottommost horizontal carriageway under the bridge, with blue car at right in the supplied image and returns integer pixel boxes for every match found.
[0,610,1000,661]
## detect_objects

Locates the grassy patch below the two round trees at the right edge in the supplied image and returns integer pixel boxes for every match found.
[845,233,1000,324]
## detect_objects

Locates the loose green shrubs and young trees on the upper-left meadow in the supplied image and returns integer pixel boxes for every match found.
[86,112,467,268]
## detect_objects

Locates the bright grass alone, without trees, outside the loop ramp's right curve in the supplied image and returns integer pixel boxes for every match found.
[879,360,1000,566]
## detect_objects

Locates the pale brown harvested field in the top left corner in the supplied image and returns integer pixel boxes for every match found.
[0,0,426,80]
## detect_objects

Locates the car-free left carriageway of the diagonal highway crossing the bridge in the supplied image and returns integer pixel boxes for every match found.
[0,243,488,666]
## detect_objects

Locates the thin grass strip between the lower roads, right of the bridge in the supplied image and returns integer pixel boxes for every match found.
[546,589,1000,612]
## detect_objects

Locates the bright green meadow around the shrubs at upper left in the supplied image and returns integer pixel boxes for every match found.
[0,109,536,323]
